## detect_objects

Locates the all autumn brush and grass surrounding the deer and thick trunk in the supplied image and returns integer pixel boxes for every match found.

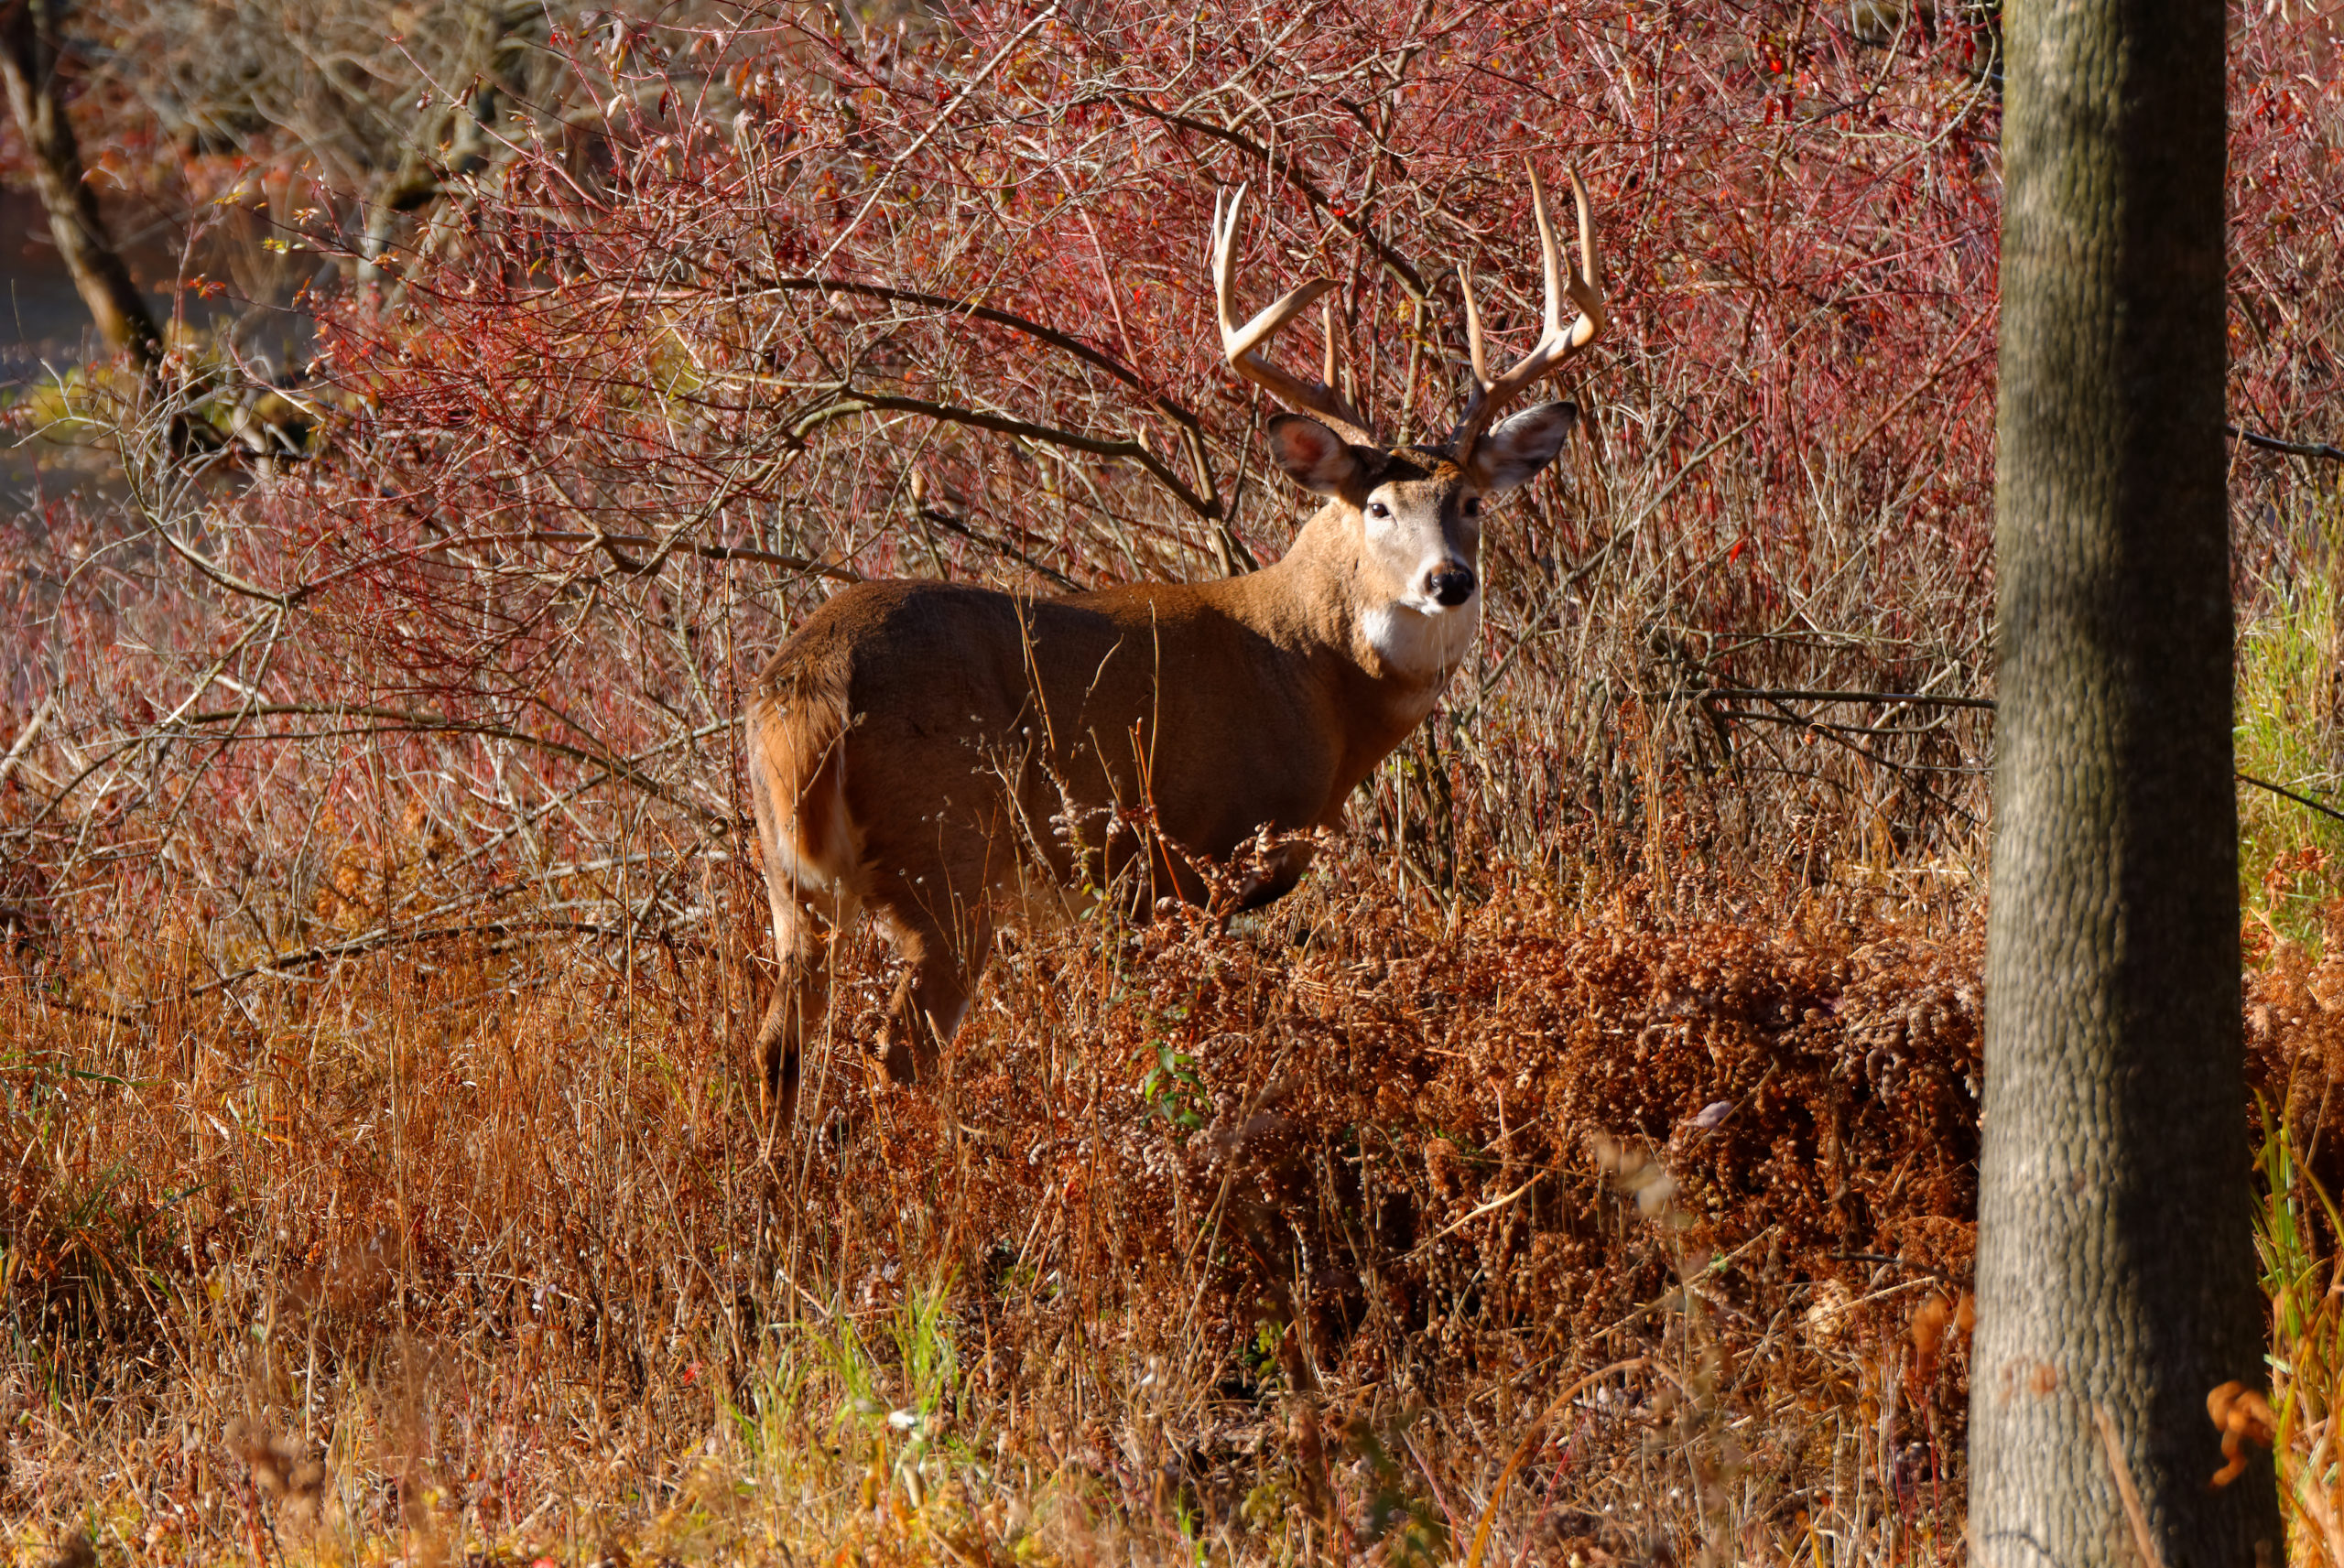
[0,0,2344,1568]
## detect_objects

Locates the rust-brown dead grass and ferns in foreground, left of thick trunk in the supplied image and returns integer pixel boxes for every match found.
[0,816,2006,1563]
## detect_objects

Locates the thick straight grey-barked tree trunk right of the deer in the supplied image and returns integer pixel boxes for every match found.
[1969,0,2281,1568]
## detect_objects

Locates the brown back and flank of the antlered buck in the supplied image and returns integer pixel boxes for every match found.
[759,581,1351,874]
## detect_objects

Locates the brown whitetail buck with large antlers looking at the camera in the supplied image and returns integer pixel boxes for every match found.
[748,173,1603,1120]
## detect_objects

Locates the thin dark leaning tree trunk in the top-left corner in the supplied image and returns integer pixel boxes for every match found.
[0,0,162,371]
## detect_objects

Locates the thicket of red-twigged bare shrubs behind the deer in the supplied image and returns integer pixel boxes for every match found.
[0,0,2344,979]
